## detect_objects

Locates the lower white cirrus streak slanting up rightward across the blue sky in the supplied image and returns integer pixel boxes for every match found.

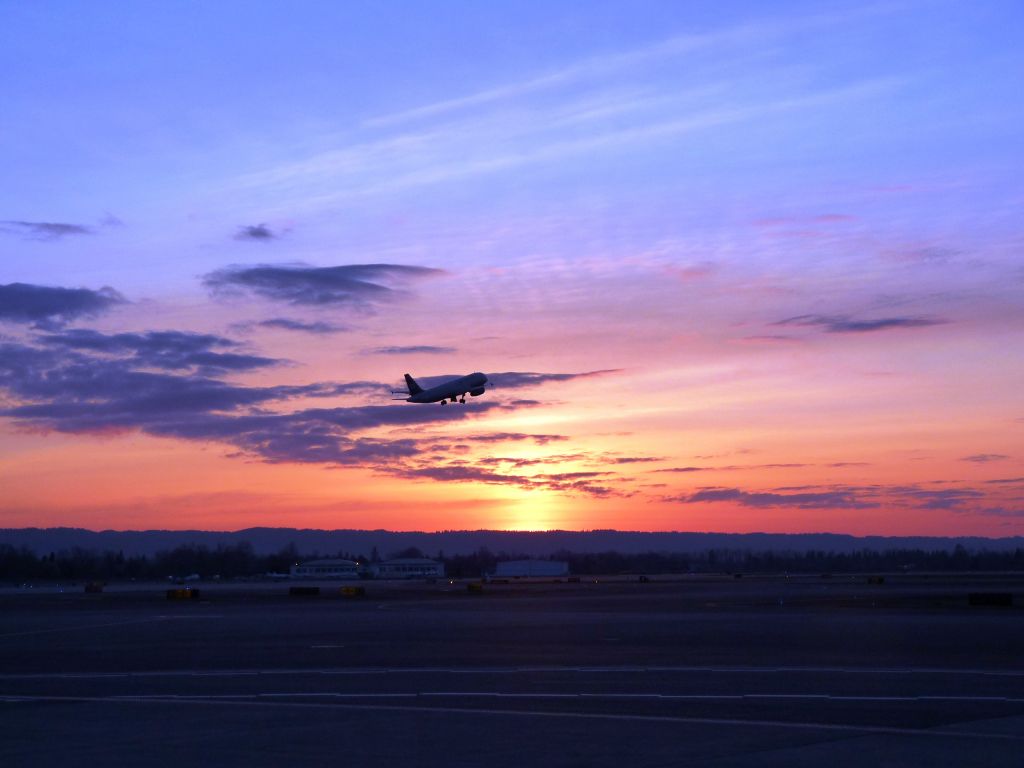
[238,78,902,209]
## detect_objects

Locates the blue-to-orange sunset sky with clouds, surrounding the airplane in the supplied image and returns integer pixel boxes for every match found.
[0,0,1024,537]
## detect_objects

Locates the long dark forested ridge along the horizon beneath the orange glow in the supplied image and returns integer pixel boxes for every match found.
[0,527,1024,557]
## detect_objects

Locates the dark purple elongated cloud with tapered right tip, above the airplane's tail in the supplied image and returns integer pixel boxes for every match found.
[203,264,444,309]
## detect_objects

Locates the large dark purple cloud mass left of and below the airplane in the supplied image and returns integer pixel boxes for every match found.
[0,331,520,464]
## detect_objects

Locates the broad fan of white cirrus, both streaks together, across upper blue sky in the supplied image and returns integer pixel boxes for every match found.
[230,6,901,212]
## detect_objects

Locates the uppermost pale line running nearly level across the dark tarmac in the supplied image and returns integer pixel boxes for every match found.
[0,663,1024,680]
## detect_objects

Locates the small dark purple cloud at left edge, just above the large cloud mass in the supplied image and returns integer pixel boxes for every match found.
[0,283,126,328]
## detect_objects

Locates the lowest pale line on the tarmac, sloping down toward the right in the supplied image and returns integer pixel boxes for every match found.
[0,694,1024,741]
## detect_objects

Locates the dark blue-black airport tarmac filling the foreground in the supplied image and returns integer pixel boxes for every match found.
[0,574,1024,768]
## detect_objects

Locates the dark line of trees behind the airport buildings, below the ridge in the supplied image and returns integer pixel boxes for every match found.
[0,543,1024,582]
